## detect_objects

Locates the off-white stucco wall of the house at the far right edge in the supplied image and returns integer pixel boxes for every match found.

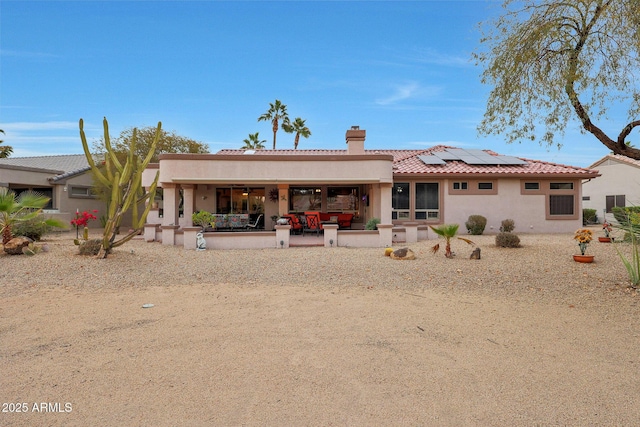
[582,160,640,222]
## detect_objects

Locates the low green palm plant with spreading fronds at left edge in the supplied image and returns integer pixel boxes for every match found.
[0,187,65,245]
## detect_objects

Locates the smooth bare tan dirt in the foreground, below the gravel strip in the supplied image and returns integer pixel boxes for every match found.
[0,232,640,426]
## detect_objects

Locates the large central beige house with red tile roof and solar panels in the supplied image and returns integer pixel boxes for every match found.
[143,126,599,247]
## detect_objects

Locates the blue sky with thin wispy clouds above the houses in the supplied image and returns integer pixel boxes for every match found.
[0,0,617,167]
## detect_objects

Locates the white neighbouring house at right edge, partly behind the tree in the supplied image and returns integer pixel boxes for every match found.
[582,154,640,222]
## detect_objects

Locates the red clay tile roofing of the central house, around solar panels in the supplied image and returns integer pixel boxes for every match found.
[216,145,599,178]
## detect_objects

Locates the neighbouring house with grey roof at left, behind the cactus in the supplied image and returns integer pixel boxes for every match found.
[0,154,104,227]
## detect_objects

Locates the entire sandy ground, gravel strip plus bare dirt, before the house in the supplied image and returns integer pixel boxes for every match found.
[0,232,640,426]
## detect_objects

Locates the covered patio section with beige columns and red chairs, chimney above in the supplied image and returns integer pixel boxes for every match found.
[143,127,410,249]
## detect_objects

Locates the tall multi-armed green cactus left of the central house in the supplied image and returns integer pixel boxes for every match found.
[80,118,162,258]
